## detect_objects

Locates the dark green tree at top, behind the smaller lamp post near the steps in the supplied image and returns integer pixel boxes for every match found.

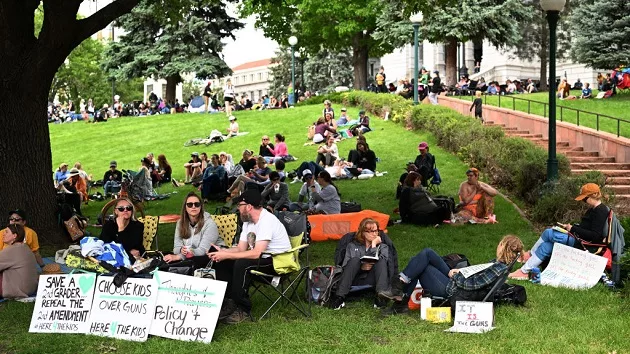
[375,0,532,85]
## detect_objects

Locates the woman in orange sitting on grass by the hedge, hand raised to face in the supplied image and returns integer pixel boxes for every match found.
[456,167,499,223]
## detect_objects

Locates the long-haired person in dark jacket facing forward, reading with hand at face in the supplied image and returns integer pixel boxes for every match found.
[331,218,394,310]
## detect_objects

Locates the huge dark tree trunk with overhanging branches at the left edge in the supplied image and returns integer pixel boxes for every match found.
[0,0,194,243]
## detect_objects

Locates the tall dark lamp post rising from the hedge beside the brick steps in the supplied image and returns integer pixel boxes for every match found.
[540,0,566,182]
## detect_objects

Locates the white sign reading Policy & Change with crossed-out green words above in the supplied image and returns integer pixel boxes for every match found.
[149,272,227,343]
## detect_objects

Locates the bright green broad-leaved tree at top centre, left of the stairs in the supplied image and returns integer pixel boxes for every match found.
[241,0,394,89]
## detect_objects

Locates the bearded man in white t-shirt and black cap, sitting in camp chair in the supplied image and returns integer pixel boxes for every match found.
[208,189,291,324]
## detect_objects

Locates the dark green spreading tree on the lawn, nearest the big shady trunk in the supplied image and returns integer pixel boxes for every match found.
[105,0,243,101]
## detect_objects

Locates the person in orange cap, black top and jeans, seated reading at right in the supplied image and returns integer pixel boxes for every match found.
[509,183,610,280]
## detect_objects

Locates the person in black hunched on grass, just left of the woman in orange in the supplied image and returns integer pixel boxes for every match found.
[398,171,451,225]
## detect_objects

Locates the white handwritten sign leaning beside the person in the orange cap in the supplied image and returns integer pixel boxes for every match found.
[540,243,606,289]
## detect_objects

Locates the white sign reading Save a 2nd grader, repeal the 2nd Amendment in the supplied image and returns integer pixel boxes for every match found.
[29,274,96,333]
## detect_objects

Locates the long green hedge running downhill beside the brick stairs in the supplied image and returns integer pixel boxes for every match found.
[320,91,605,224]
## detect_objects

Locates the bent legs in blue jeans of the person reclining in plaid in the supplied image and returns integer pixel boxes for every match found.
[400,248,450,298]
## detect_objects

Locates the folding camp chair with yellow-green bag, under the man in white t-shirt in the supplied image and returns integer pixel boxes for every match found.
[250,212,311,319]
